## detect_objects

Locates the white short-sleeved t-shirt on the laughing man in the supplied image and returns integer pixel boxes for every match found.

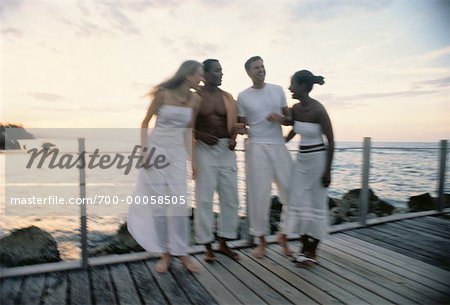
[237,83,287,144]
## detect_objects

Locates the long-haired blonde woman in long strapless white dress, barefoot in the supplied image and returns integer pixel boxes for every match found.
[128,60,203,273]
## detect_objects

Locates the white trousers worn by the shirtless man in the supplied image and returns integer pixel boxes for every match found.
[194,139,239,244]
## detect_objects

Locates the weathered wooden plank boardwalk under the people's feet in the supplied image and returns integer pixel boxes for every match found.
[0,216,450,305]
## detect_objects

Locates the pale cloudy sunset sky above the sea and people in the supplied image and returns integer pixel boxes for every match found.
[0,0,450,142]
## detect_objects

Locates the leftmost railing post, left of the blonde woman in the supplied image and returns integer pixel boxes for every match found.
[78,138,88,269]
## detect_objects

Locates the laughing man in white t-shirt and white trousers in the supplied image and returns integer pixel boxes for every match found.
[237,56,292,258]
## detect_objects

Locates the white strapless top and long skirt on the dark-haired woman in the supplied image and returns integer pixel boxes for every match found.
[285,121,328,240]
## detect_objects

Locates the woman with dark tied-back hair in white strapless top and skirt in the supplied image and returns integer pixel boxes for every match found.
[286,70,334,267]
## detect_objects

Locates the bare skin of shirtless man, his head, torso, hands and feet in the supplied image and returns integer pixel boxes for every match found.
[195,62,239,262]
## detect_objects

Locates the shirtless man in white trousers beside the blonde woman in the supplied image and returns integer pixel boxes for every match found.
[194,59,239,262]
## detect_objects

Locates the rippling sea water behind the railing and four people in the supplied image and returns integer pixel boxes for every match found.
[0,142,450,259]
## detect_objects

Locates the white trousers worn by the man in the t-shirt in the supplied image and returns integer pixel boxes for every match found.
[245,143,293,237]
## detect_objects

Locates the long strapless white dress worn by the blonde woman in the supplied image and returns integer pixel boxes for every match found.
[127,104,192,255]
